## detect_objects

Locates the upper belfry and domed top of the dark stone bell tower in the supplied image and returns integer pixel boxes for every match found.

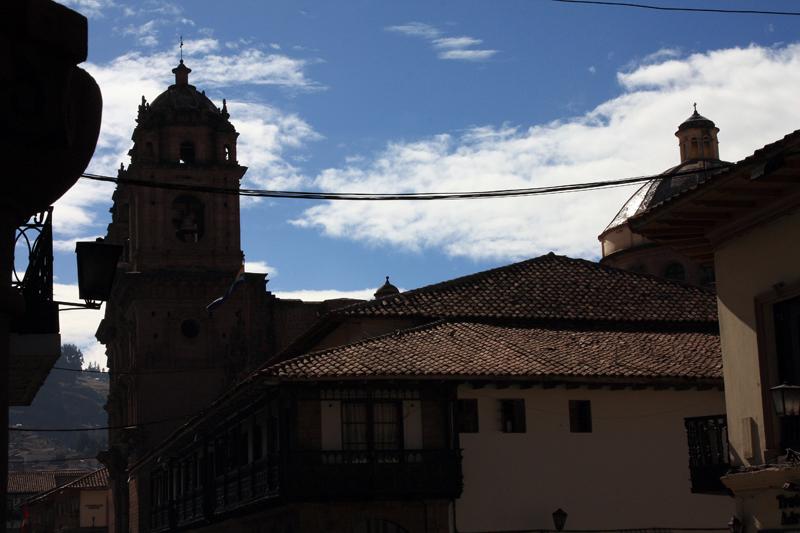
[109,60,247,272]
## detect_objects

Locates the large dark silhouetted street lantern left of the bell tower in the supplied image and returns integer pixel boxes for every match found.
[75,239,122,304]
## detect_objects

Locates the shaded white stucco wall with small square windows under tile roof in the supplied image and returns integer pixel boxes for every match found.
[456,386,734,533]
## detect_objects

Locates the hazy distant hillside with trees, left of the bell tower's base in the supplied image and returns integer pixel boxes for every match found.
[8,344,108,470]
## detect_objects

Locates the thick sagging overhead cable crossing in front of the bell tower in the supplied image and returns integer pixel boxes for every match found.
[81,167,719,201]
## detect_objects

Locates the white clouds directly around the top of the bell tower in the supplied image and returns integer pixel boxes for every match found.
[54,42,319,242]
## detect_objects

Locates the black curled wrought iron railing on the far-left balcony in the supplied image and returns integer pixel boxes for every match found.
[11,207,58,333]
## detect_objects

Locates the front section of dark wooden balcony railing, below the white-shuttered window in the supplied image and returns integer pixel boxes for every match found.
[285,450,462,499]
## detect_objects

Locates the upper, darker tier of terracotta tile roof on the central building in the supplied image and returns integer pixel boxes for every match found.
[332,254,717,323]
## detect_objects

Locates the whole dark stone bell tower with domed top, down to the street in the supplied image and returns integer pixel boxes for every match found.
[97,60,273,533]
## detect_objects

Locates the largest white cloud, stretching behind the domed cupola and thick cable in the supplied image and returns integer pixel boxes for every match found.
[293,44,800,260]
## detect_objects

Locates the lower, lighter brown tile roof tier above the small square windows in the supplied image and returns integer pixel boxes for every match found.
[261,322,722,380]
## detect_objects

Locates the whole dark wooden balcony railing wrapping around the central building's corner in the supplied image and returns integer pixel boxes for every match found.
[150,450,462,531]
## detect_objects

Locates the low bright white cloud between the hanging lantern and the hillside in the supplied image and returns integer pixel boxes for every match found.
[53,283,106,368]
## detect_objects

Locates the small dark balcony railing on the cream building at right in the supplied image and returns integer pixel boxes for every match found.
[684,415,730,494]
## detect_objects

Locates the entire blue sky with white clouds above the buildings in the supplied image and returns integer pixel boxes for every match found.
[54,0,800,364]
